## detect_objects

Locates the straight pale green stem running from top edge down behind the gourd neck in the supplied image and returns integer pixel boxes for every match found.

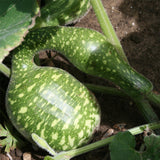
[91,0,128,62]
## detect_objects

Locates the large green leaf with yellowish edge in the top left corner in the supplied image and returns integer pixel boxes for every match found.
[0,0,39,63]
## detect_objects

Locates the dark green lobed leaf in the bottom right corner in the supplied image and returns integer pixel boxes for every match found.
[109,132,160,160]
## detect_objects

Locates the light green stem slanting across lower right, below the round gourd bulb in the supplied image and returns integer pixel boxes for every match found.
[54,122,160,160]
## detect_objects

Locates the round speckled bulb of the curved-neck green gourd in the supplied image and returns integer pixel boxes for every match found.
[6,65,100,151]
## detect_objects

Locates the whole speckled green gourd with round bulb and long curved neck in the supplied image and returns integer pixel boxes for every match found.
[6,27,152,151]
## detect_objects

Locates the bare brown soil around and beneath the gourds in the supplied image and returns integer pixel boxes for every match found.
[0,0,160,160]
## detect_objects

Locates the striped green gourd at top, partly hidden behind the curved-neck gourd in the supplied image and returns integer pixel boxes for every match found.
[34,0,90,28]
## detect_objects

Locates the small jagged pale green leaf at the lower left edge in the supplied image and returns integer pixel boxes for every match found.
[0,124,17,153]
